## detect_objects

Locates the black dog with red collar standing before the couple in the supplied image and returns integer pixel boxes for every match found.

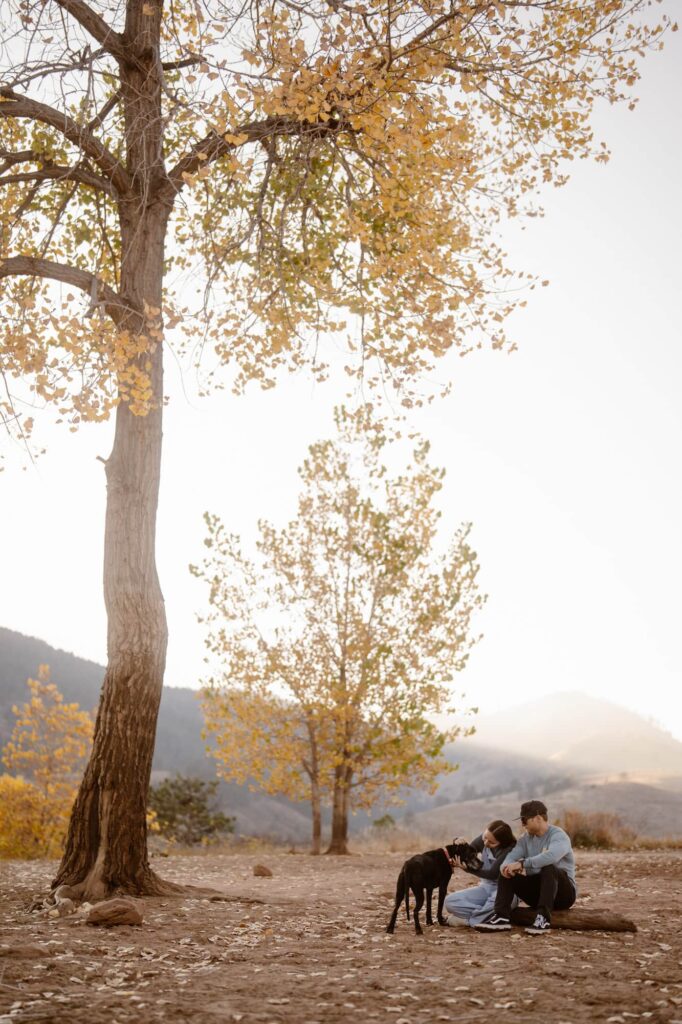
[386,843,480,935]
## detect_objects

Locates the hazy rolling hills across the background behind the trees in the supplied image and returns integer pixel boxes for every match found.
[5,628,682,843]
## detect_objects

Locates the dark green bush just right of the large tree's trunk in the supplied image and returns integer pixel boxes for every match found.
[150,775,235,846]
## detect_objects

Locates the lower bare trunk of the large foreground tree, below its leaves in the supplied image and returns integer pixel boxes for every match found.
[53,346,167,899]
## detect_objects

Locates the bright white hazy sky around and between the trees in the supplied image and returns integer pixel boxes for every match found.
[0,28,682,748]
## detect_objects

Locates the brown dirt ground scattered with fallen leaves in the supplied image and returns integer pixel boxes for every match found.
[0,851,682,1024]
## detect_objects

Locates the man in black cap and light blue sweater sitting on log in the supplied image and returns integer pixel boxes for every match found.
[476,800,577,935]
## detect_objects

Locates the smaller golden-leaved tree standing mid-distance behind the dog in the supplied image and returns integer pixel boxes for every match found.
[194,407,482,853]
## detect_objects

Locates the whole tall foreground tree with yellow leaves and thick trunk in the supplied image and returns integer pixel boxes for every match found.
[0,0,669,897]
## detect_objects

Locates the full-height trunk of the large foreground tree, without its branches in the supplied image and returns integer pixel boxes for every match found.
[53,0,177,898]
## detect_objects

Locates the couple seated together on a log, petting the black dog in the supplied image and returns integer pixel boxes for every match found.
[444,800,577,935]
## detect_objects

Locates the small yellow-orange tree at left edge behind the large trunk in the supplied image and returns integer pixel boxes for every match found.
[2,665,93,857]
